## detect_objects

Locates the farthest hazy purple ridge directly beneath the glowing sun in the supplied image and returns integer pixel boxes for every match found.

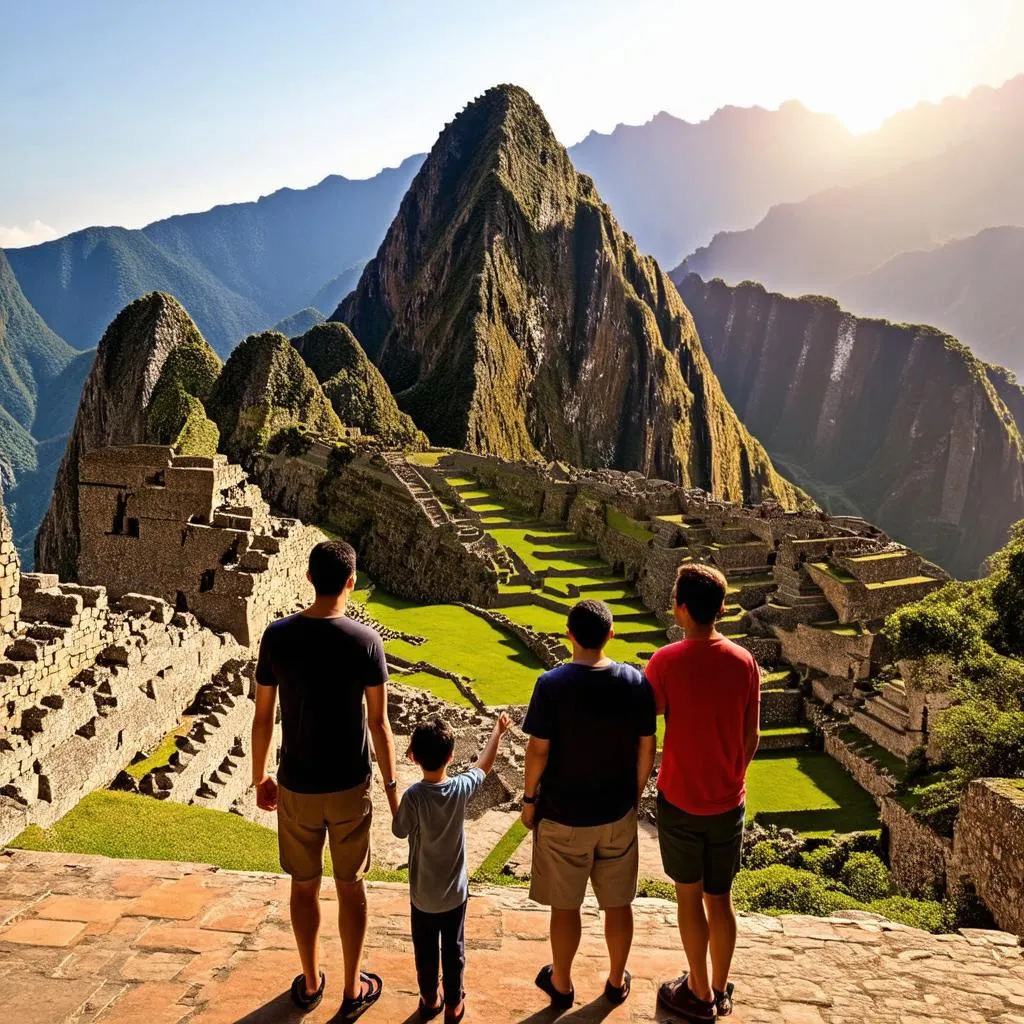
[569,77,1024,268]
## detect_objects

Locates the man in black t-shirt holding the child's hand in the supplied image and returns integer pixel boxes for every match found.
[252,541,398,1020]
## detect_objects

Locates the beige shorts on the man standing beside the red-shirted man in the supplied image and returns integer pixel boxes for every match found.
[529,811,640,910]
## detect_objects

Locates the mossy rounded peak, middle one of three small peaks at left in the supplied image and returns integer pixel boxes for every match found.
[207,331,344,462]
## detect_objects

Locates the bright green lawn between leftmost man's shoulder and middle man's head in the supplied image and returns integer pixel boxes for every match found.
[367,588,544,705]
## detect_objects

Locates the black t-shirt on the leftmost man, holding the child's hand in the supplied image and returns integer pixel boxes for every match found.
[256,614,387,793]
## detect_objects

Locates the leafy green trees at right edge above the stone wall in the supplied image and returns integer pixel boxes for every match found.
[884,521,1024,833]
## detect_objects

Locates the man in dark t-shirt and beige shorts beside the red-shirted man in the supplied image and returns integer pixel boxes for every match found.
[522,601,656,1010]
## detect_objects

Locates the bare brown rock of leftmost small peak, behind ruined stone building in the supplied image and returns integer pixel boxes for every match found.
[36,292,219,580]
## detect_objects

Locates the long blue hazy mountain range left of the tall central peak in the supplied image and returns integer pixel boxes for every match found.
[8,157,422,354]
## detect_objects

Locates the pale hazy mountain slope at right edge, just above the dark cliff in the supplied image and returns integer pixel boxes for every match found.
[837,226,1024,380]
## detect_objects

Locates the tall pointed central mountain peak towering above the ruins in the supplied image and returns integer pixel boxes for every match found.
[332,86,794,500]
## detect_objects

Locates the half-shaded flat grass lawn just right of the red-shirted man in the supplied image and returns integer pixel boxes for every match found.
[746,751,879,835]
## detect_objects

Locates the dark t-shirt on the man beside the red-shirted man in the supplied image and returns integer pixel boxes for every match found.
[522,663,657,828]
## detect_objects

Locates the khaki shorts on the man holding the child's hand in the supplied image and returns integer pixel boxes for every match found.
[278,778,374,883]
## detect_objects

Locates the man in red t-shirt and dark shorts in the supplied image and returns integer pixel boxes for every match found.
[646,563,761,1021]
